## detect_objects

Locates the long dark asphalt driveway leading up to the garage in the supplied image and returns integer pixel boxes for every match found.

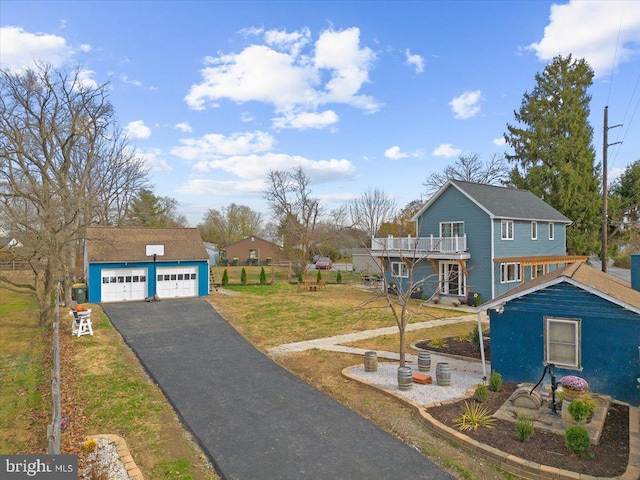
[102,298,453,480]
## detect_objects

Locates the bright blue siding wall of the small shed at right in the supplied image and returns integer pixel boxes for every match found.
[489,283,640,406]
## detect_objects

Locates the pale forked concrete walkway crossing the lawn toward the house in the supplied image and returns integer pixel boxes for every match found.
[267,315,491,374]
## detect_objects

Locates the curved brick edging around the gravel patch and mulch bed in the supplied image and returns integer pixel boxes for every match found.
[342,364,640,480]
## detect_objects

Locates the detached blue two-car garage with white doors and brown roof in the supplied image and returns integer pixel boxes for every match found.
[85,227,209,303]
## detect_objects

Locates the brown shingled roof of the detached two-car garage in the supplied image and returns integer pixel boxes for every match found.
[86,227,209,263]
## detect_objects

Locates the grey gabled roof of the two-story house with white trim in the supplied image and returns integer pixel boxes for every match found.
[412,180,571,223]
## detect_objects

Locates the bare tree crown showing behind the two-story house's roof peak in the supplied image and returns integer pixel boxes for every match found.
[422,153,510,197]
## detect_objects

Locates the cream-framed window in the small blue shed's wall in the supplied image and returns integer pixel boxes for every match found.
[544,317,581,369]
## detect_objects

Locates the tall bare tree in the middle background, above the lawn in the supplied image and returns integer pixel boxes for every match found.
[264,167,320,262]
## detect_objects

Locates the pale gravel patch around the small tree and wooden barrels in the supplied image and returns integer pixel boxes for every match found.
[348,362,482,405]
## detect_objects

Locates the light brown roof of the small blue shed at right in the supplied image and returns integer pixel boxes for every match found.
[478,262,640,314]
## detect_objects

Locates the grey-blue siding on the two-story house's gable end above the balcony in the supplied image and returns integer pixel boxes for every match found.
[418,186,493,300]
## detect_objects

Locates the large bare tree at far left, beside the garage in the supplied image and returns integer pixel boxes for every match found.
[0,65,146,325]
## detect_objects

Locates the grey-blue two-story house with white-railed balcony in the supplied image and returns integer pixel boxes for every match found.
[371,180,587,301]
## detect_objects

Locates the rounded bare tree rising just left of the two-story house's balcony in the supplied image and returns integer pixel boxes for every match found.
[349,188,396,239]
